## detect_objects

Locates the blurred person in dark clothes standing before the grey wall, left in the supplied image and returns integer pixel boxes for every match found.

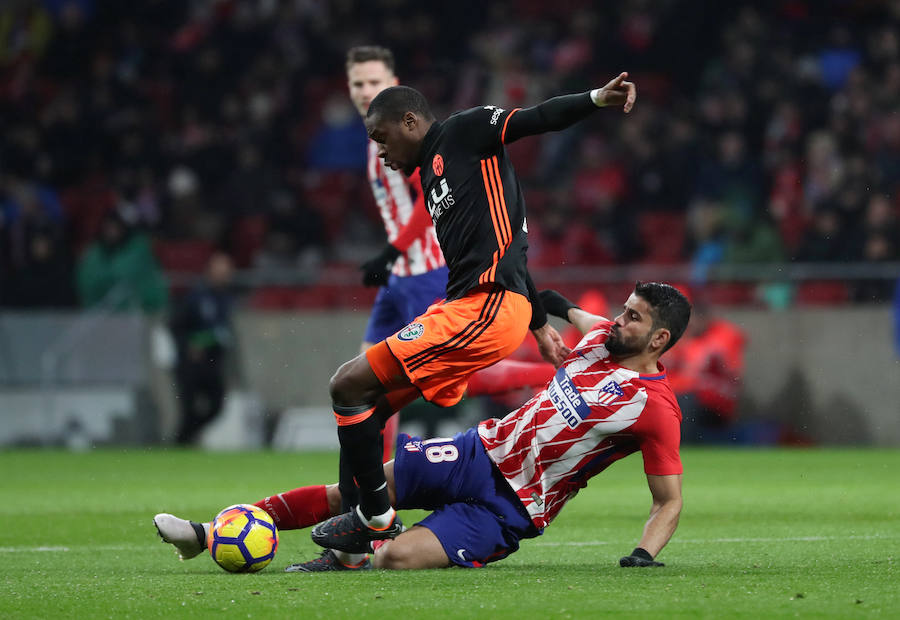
[169,252,235,445]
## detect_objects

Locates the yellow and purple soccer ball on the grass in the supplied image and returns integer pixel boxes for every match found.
[206,504,278,573]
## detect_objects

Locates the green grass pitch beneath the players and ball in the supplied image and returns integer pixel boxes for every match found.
[0,449,900,619]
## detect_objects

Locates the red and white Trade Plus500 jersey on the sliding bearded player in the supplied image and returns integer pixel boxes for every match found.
[478,321,682,528]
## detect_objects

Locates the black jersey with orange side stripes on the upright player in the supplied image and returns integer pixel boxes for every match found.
[419,93,597,299]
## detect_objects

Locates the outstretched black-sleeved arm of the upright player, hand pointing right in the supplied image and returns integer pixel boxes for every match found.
[501,72,637,144]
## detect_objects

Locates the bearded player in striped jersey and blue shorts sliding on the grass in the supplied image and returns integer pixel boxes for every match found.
[154,282,691,572]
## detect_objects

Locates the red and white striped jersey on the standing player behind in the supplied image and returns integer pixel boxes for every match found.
[368,140,446,276]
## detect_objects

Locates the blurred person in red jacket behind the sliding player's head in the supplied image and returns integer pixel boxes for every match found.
[666,298,746,443]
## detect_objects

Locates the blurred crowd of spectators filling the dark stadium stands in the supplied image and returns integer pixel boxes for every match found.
[0,0,900,311]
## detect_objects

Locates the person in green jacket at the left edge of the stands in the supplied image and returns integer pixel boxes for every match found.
[76,209,169,313]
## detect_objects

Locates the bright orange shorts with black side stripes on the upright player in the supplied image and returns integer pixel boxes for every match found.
[366,285,531,407]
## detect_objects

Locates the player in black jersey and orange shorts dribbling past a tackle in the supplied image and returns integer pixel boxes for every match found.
[312,73,636,554]
